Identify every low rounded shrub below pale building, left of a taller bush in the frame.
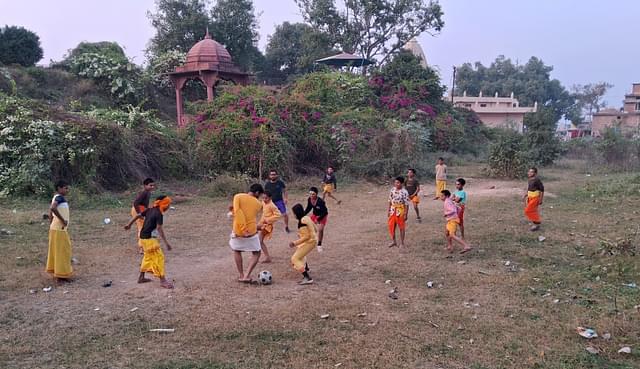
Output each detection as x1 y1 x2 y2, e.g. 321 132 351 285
488 130 528 178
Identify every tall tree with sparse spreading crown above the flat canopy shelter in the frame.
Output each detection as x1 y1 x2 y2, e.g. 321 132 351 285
295 0 444 64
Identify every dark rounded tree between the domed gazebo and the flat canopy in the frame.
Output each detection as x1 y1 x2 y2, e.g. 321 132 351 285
262 22 331 83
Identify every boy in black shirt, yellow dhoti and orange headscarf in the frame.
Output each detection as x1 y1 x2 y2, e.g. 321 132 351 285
124 196 173 288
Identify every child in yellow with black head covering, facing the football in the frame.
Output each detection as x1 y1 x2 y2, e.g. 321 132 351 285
289 201 317 285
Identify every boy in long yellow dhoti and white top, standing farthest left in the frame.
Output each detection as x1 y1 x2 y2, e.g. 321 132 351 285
46 181 73 282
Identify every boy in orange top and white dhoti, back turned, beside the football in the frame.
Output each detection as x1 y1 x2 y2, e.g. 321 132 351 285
229 183 264 283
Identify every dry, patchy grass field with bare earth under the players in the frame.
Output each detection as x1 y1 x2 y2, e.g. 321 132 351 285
0 163 640 369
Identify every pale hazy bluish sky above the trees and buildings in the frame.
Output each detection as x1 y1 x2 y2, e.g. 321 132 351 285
0 0 640 107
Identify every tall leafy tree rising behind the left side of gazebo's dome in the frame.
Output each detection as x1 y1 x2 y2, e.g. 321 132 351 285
147 0 210 57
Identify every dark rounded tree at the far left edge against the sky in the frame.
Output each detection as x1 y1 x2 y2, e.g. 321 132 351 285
0 26 43 67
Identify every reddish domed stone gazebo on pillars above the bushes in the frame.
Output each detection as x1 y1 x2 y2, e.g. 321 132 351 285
169 30 250 127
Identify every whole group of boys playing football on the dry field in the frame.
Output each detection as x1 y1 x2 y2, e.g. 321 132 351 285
46 158 544 288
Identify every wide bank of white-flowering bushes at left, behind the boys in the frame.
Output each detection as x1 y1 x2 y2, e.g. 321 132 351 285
0 93 187 196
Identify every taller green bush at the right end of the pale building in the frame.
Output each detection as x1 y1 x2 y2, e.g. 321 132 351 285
524 108 562 166
